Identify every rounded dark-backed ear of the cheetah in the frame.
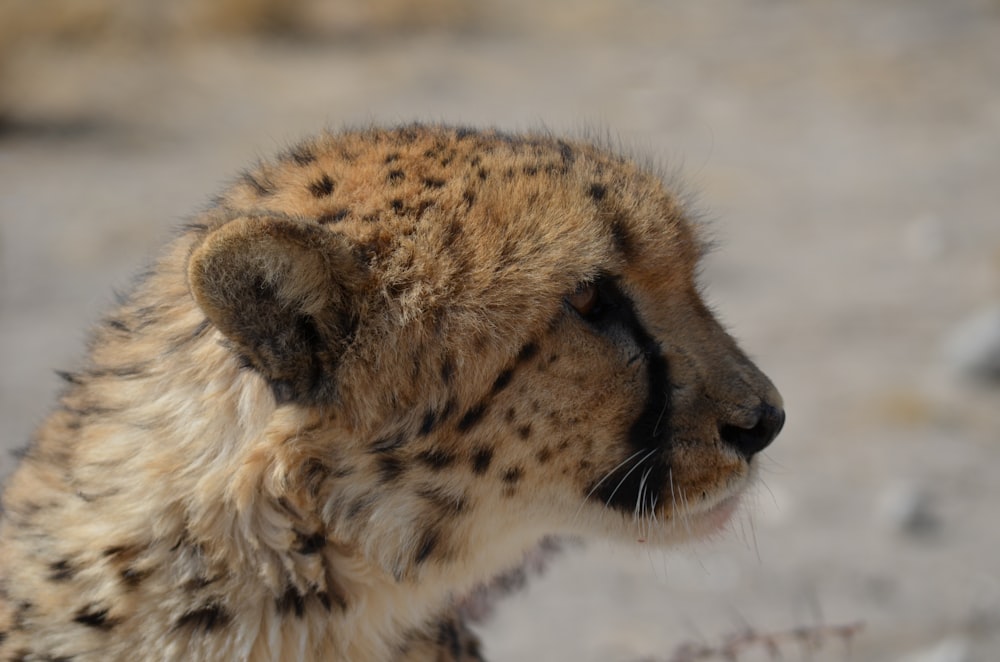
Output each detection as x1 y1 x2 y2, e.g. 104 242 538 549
188 216 365 404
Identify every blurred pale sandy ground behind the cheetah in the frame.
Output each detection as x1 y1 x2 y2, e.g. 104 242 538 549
0 0 1000 662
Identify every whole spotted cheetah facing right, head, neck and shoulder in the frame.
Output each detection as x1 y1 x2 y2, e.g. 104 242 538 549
0 124 785 662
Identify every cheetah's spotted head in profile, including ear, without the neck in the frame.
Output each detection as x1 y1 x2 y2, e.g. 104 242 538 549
188 126 784 576
